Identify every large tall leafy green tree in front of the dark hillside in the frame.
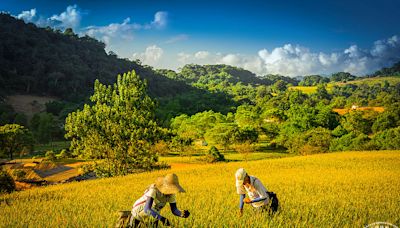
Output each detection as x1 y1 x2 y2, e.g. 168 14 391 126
65 71 163 176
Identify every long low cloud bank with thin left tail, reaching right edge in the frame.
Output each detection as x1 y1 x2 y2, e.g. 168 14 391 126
177 36 400 76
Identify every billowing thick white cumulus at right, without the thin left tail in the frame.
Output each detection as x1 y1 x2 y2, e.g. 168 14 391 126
258 36 400 76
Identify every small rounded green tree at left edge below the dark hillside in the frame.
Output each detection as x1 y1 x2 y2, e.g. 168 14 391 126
0 124 30 160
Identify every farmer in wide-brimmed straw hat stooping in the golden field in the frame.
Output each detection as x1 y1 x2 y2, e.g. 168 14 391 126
130 174 190 227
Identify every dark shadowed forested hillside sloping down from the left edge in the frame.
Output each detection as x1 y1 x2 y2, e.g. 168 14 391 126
0 14 195 101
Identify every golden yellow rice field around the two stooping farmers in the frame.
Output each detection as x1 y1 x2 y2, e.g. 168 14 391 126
0 151 400 227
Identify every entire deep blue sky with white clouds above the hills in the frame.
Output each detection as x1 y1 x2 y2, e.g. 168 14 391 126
0 0 400 76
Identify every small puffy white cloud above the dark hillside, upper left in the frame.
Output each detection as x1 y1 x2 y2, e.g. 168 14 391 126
48 5 82 29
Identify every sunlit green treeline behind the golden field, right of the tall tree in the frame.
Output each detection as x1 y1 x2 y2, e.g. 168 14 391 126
171 80 400 154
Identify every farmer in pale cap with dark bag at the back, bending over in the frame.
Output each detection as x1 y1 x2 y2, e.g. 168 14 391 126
235 168 278 216
